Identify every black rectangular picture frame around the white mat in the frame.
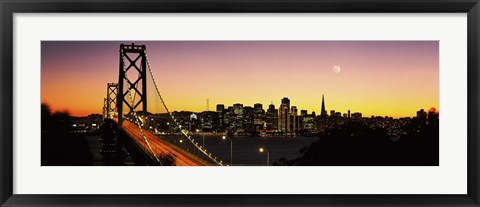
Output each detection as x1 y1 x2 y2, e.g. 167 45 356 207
0 0 480 206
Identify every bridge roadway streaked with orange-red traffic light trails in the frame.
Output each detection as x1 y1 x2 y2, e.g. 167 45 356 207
115 120 212 166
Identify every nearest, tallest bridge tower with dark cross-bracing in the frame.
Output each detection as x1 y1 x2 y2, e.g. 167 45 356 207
117 43 147 124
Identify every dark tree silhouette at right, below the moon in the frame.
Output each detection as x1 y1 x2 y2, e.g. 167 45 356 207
274 108 439 166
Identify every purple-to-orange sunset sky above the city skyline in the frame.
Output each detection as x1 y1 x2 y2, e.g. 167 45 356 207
41 41 439 118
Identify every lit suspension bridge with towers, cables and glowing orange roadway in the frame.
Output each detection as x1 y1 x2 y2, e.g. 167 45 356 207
103 43 224 166
